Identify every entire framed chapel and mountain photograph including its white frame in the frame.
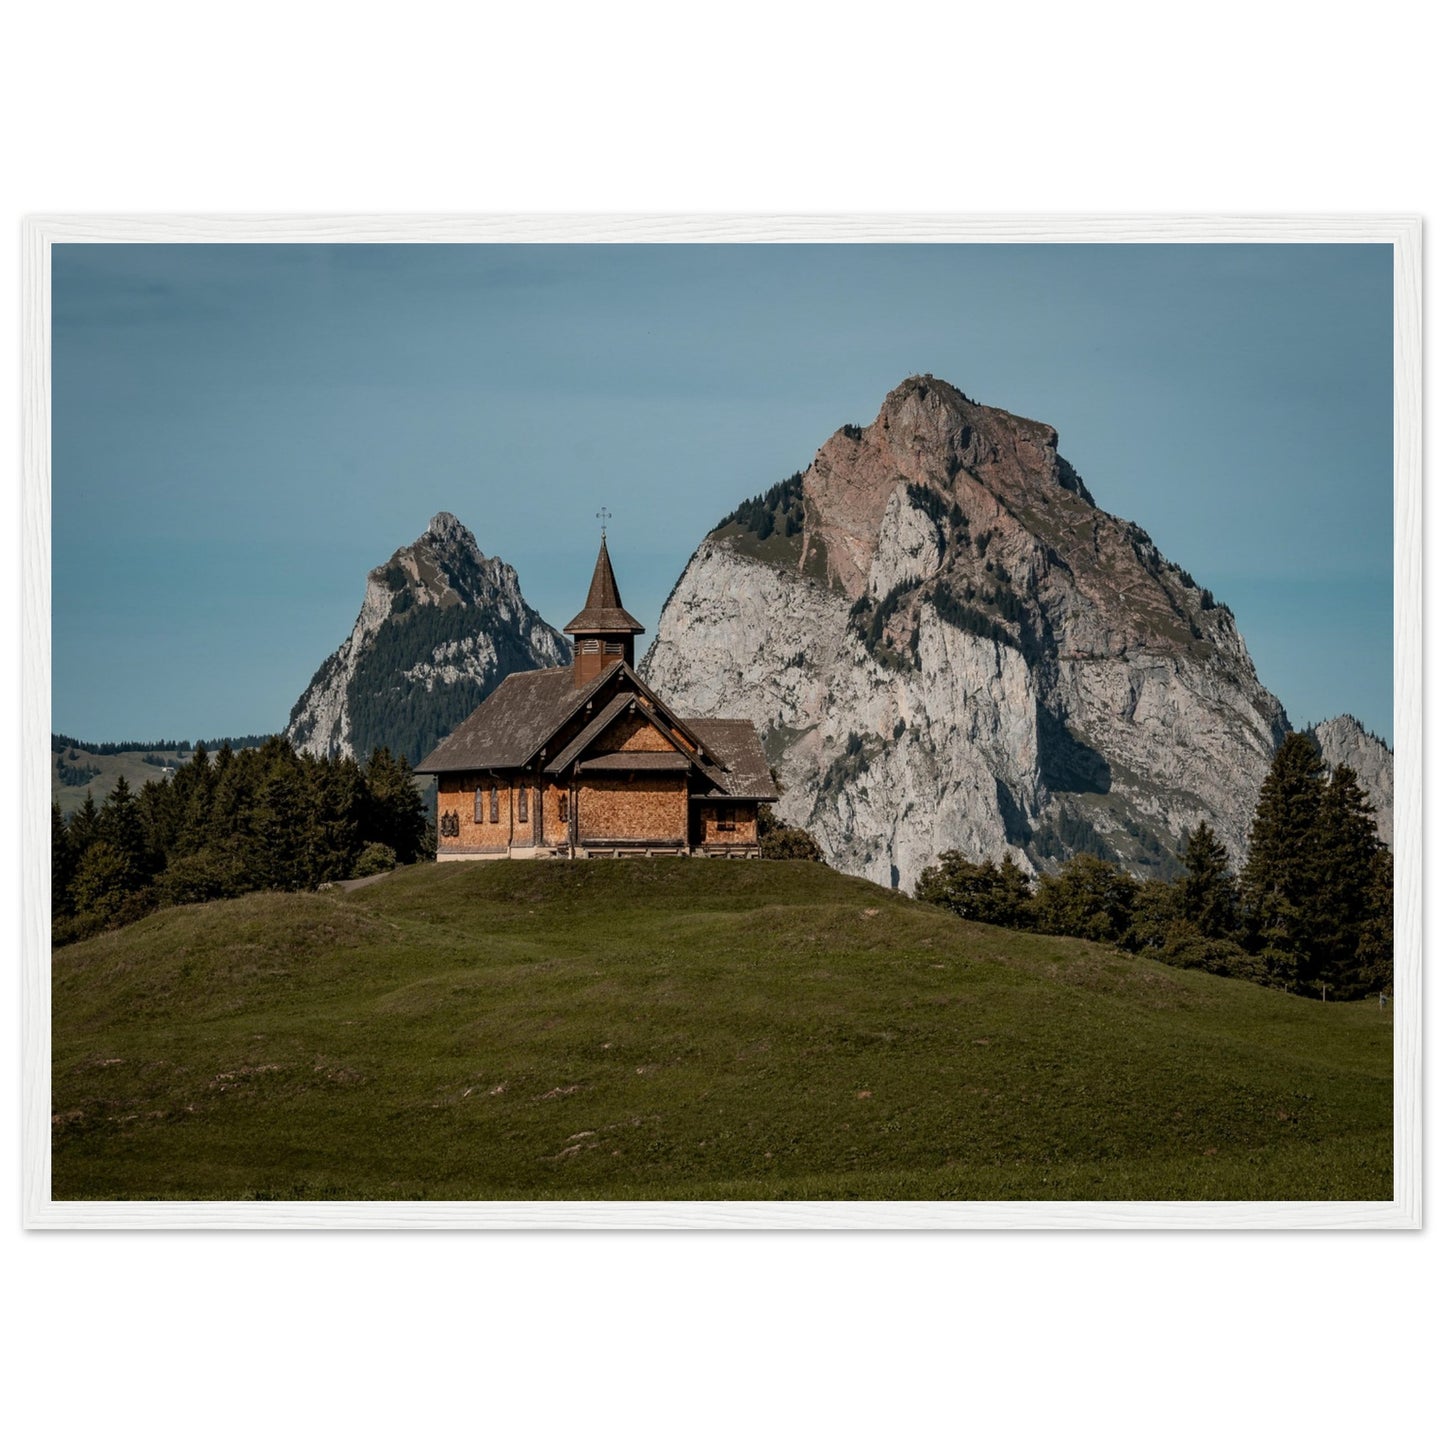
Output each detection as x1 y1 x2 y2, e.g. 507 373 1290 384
23 217 1422 1228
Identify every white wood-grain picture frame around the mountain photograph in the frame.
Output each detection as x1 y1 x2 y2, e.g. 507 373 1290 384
20 215 1423 1230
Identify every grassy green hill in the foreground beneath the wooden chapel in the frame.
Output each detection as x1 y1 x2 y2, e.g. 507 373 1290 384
53 858 1392 1199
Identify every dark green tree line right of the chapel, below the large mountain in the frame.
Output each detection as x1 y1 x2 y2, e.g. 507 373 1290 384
915 733 1394 998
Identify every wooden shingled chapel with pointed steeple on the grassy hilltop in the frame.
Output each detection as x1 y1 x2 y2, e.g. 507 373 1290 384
416 532 777 861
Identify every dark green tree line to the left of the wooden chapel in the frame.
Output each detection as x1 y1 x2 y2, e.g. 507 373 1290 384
51 737 429 945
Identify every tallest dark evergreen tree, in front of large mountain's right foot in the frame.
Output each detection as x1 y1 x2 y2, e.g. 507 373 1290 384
1240 733 1325 987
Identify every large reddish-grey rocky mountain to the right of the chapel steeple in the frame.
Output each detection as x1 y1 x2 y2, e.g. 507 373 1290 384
642 376 1289 887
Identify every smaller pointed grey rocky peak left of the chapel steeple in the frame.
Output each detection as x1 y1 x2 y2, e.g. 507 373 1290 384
286 512 572 763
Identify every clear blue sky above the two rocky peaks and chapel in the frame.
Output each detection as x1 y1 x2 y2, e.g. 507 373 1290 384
52 246 1393 741
